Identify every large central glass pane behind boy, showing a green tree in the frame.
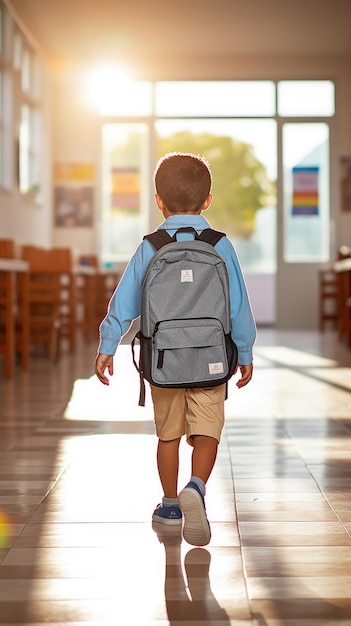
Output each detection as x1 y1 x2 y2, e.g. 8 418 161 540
155 119 277 325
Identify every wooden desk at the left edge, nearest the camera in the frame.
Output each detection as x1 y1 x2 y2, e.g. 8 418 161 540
0 259 29 378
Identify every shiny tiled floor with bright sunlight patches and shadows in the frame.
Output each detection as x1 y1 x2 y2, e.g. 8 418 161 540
0 330 351 626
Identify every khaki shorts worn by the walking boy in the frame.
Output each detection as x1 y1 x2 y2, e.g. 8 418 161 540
151 384 226 445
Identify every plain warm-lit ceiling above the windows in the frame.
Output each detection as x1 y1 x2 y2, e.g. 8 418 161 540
5 0 351 69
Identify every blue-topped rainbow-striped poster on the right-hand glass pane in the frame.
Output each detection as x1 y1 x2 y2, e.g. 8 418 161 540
291 166 319 215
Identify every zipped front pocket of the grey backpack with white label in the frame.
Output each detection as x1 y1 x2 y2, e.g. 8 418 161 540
152 318 228 387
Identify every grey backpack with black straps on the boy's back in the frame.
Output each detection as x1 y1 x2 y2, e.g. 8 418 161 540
132 227 238 406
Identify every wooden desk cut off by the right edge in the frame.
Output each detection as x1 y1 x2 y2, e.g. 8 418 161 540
333 257 351 347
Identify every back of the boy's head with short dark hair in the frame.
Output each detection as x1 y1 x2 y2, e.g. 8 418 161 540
154 152 211 213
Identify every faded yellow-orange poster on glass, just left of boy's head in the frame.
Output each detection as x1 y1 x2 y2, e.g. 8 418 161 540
111 167 140 211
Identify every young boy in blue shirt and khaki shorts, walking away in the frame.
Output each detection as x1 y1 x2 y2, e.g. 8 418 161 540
95 153 256 546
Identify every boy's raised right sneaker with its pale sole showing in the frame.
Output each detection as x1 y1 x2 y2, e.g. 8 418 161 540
179 481 211 546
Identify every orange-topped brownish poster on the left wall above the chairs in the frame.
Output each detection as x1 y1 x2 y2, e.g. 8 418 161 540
54 163 95 227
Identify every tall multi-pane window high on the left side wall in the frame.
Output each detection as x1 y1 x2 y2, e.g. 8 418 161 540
0 0 43 195
